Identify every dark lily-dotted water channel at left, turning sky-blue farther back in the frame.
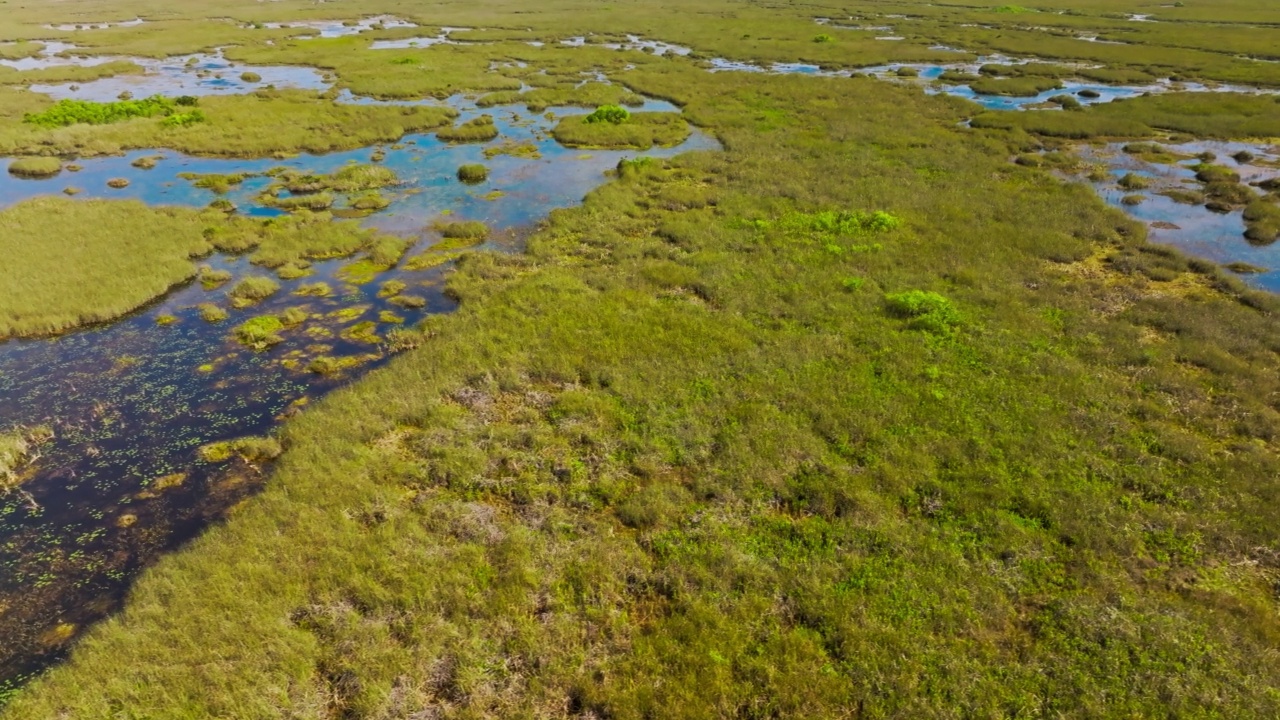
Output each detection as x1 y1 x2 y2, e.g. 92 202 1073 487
0 96 718 701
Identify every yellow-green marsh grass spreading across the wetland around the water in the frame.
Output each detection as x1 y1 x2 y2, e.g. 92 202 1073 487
0 0 1280 720
